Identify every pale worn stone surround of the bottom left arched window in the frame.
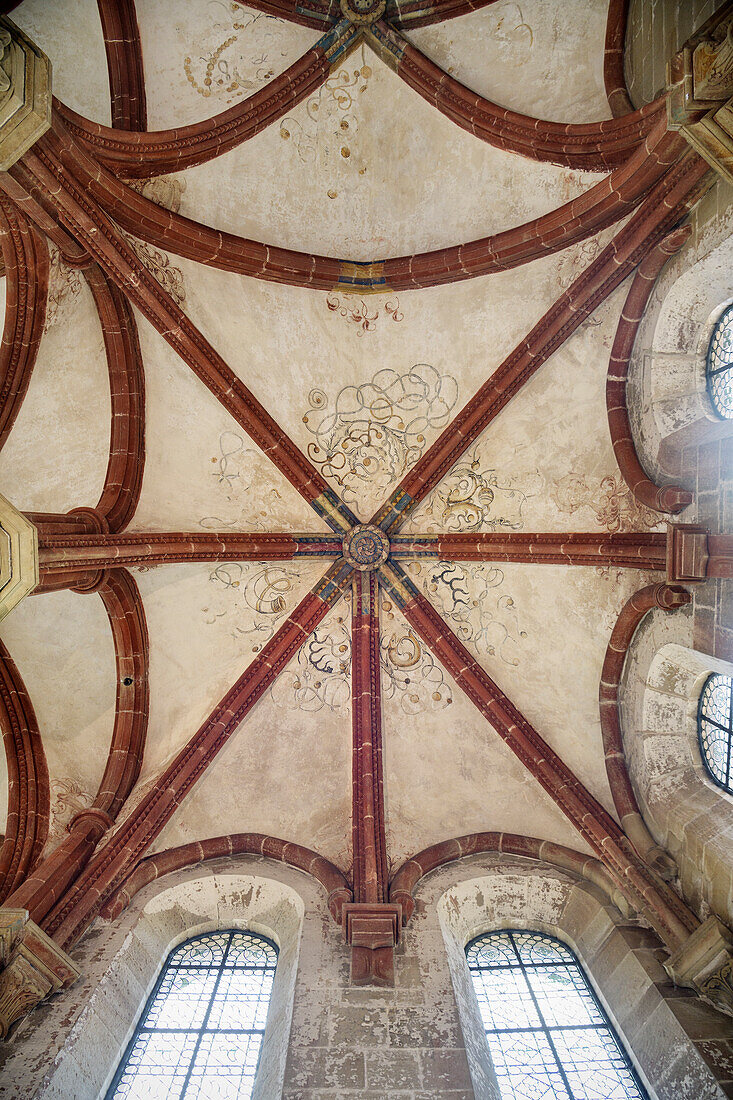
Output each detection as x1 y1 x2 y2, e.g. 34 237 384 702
19 865 305 1100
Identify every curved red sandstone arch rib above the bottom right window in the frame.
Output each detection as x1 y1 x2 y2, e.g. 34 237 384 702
390 833 619 924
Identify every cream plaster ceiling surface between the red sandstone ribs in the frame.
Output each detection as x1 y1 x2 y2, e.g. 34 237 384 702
0 0 654 867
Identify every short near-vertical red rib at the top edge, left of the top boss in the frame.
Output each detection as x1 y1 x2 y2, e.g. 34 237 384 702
97 0 147 130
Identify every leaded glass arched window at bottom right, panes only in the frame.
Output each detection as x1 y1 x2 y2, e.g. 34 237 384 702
466 931 646 1100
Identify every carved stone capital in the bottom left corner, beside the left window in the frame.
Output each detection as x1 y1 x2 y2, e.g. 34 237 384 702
0 909 80 1038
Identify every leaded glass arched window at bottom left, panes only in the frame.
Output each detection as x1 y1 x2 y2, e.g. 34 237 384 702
107 930 277 1100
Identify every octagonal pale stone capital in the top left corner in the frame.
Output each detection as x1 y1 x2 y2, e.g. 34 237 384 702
0 15 51 172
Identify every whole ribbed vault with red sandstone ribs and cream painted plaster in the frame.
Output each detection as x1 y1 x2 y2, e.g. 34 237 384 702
0 0 730 1003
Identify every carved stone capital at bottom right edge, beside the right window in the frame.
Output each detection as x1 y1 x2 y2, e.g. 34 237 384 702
665 916 733 1016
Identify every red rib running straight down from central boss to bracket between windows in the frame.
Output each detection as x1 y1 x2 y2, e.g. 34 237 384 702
351 570 387 903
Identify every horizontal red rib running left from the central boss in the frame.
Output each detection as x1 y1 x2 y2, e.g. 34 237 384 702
39 528 341 584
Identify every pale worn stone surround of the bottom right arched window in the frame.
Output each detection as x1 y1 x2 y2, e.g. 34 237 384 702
416 855 726 1100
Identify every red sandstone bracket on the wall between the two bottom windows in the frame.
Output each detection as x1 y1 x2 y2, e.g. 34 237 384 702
341 902 402 986
